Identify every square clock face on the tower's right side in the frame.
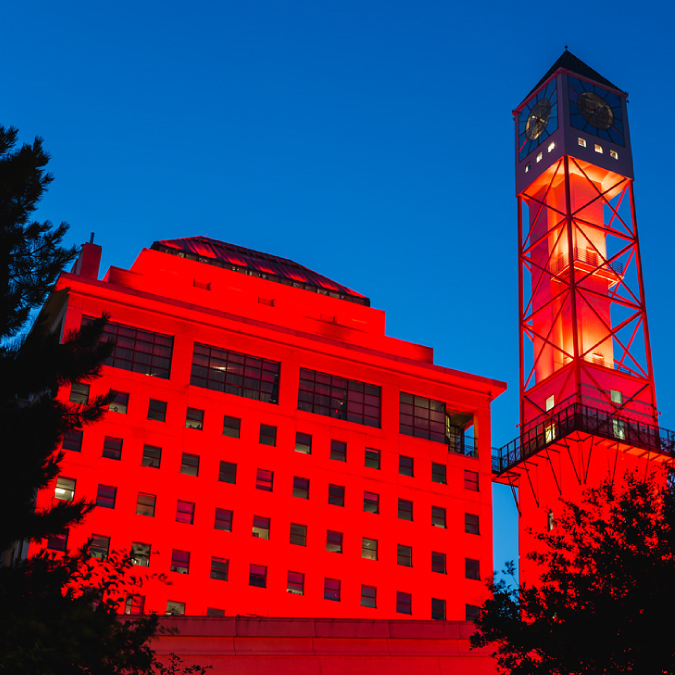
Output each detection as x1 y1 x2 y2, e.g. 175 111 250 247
568 76 626 145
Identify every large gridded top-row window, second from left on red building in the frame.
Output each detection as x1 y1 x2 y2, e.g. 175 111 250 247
190 342 280 403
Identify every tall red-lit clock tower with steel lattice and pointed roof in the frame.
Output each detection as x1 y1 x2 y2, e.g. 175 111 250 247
495 51 671 581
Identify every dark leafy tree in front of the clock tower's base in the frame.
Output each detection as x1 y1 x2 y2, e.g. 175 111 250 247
471 474 675 675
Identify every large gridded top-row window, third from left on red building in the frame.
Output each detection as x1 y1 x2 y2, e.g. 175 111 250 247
298 368 382 429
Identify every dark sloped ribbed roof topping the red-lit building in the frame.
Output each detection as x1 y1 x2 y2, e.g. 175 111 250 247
151 237 370 306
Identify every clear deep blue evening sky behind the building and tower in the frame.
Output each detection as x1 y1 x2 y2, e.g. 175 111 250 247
5 0 675 580
